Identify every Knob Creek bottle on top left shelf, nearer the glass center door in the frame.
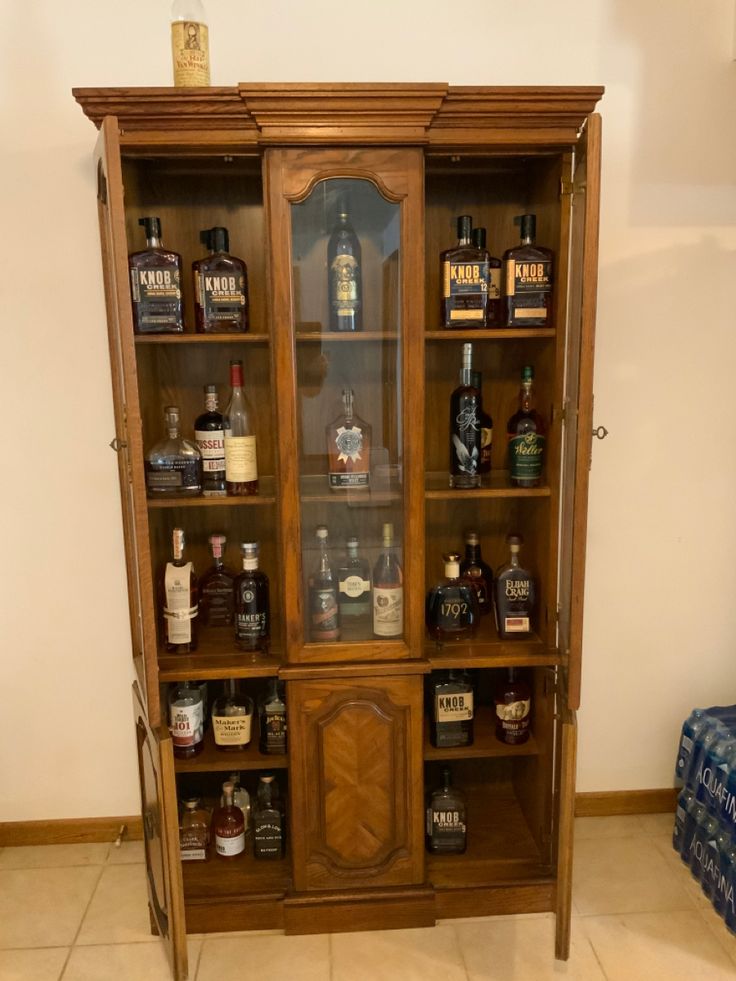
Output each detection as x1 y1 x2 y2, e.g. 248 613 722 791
192 225 248 334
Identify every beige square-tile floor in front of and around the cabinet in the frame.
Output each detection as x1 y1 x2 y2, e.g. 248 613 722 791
0 814 736 981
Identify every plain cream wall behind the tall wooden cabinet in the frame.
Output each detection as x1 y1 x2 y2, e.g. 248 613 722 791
0 0 736 820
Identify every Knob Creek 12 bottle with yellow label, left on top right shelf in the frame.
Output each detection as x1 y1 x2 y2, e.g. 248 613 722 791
440 215 488 327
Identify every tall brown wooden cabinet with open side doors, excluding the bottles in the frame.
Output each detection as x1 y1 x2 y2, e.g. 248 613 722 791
75 84 602 978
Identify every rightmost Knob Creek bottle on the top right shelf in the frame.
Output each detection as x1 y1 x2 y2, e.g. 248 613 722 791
503 215 553 327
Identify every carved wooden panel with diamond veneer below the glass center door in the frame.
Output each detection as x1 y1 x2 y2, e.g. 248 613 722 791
287 677 423 890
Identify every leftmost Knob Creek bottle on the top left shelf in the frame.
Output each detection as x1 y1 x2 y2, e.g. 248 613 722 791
128 216 184 334
